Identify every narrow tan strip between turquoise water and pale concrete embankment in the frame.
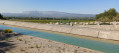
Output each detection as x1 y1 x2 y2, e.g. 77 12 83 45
0 24 119 44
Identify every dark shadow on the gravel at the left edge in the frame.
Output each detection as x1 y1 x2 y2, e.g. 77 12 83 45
0 34 22 53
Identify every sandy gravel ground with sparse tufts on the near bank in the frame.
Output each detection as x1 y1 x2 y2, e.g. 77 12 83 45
0 34 103 53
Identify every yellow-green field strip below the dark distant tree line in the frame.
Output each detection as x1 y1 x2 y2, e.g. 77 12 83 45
10 19 94 23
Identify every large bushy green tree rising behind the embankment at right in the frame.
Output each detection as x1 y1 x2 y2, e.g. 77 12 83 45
95 8 117 22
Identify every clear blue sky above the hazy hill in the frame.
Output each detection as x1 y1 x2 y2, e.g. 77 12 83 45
0 0 119 14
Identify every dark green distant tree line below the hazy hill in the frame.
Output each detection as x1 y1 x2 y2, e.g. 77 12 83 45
4 17 93 20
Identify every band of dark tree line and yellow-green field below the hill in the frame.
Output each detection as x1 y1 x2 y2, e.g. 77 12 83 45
5 17 94 23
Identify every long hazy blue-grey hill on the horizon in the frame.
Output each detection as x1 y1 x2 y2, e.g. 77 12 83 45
2 11 95 18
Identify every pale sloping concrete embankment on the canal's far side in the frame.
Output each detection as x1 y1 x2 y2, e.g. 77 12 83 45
0 20 119 40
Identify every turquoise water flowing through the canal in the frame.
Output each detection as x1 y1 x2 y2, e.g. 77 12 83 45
0 25 119 53
